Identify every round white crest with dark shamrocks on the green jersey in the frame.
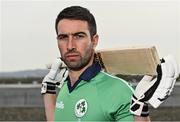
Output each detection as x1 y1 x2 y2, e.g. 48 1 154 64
74 99 88 117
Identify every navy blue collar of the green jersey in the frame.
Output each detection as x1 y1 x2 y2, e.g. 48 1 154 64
67 62 101 93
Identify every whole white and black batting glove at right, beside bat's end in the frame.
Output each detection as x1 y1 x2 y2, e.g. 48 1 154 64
130 56 179 117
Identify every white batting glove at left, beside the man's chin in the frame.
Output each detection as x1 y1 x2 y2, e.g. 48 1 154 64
41 58 68 94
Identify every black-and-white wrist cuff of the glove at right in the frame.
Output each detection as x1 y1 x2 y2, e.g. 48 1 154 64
130 95 149 117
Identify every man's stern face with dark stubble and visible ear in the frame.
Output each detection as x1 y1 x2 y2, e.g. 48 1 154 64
57 19 98 70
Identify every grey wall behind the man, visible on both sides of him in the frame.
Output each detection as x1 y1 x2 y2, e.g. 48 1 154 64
0 84 180 107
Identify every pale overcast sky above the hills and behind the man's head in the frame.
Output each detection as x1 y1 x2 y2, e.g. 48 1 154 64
0 0 180 72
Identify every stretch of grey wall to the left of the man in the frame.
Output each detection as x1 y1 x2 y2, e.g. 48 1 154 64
0 84 44 107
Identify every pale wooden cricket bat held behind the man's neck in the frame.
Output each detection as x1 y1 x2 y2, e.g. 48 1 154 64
96 46 160 75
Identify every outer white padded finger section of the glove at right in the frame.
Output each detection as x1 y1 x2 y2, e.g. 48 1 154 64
148 55 179 108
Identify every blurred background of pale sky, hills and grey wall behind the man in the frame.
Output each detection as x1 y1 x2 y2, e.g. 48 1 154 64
0 0 180 121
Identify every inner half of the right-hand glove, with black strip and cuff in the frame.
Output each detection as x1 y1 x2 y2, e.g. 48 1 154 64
130 73 161 117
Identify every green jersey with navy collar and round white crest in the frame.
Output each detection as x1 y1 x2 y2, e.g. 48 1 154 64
54 63 134 121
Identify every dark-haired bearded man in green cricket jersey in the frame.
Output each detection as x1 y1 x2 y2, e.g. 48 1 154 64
42 6 179 121
